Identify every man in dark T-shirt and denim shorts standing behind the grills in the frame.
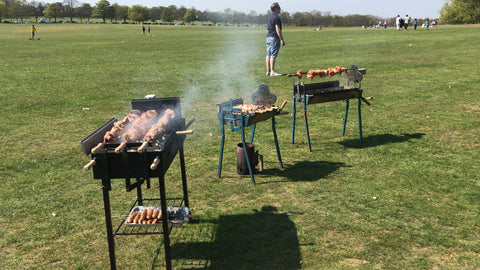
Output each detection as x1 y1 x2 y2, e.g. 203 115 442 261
266 2 285 76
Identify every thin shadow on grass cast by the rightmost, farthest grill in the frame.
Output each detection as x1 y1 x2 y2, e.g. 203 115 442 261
339 133 426 148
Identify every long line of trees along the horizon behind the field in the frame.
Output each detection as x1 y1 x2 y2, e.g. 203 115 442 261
0 0 480 27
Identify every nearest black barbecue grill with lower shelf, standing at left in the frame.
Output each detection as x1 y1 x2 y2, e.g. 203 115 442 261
81 98 193 269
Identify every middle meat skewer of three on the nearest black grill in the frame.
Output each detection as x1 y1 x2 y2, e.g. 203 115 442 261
115 110 158 154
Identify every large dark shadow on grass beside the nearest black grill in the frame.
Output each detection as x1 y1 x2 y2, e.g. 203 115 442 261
158 206 301 270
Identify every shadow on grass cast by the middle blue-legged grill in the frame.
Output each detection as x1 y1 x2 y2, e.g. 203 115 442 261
257 160 346 184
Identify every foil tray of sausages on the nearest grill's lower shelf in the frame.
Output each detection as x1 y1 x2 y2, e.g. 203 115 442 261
125 206 190 227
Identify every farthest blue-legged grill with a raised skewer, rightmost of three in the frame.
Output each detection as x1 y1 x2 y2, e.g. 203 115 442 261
291 65 370 152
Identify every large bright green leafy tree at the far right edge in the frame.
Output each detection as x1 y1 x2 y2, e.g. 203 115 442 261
440 0 480 23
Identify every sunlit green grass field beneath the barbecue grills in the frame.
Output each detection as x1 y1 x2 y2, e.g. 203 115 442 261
0 24 480 269
